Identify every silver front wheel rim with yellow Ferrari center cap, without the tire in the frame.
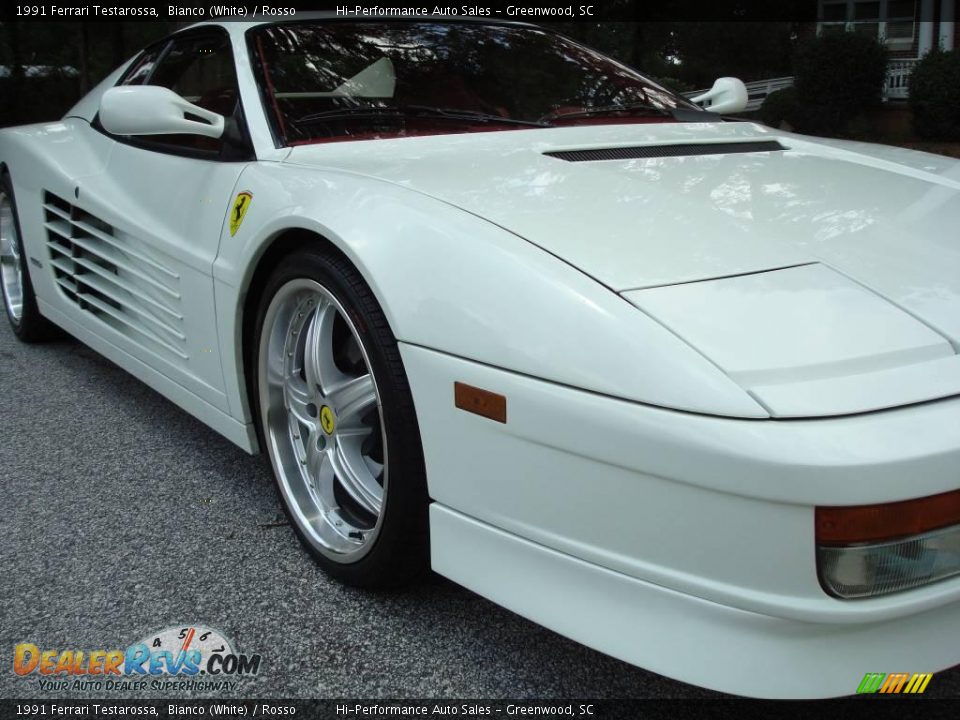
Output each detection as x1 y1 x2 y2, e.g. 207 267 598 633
258 278 388 563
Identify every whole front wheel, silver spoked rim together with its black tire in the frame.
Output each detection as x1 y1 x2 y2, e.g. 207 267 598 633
255 252 427 586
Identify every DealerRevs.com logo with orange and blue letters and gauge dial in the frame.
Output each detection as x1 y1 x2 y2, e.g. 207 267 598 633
13 625 262 691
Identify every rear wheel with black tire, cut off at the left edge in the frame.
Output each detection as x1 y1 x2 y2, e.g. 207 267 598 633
0 173 56 342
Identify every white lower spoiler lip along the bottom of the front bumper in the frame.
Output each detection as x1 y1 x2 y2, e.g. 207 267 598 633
430 504 960 698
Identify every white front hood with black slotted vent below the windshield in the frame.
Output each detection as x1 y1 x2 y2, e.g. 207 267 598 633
288 123 960 416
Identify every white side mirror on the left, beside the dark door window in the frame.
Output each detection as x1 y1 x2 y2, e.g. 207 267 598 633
100 85 224 138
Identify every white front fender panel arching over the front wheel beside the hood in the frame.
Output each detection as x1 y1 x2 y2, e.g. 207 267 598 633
214 163 767 419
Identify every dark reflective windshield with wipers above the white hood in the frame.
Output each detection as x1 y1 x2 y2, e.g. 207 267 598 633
250 21 698 145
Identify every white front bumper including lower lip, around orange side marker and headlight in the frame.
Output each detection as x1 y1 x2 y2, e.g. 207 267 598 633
402 345 960 697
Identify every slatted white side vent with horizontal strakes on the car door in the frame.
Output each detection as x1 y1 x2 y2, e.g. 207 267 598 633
43 192 188 360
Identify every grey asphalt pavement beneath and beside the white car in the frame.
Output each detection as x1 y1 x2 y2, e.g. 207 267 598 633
0 317 960 698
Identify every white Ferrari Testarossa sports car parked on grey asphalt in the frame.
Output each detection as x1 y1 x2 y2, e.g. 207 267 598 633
0 17 960 697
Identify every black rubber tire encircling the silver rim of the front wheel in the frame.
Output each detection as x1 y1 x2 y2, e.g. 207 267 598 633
248 248 429 589
